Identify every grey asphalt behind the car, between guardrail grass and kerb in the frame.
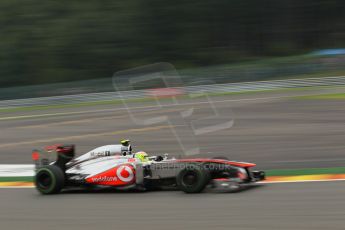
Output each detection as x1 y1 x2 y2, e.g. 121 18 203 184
0 87 345 169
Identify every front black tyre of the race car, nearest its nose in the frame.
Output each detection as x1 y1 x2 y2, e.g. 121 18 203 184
176 164 210 193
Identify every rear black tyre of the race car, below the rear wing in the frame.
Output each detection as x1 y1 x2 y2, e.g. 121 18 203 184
35 165 65 194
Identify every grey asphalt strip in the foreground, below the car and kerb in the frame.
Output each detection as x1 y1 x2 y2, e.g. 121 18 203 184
0 181 345 230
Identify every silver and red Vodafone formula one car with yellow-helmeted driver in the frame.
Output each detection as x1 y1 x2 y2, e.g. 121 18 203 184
32 144 265 194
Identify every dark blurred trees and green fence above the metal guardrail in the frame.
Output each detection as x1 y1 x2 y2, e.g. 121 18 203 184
0 0 345 99
